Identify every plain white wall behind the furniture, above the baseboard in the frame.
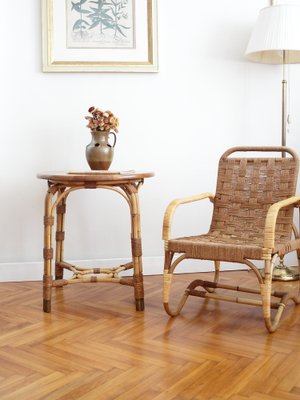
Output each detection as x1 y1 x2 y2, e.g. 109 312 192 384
0 0 300 280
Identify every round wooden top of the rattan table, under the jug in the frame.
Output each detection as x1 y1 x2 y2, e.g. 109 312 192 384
37 170 154 183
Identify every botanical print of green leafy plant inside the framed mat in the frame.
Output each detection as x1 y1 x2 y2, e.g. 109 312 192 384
66 0 135 48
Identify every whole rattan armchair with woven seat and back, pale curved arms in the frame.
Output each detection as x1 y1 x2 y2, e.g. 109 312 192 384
163 147 300 332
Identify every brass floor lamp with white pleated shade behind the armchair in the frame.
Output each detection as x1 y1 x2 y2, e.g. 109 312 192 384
245 1 300 281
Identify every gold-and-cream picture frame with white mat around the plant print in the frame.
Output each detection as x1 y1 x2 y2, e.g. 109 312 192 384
42 0 158 72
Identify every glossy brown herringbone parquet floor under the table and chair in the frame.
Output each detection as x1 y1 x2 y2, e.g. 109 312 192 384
0 271 300 400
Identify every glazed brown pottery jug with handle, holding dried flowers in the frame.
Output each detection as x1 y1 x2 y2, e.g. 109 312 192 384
85 130 117 170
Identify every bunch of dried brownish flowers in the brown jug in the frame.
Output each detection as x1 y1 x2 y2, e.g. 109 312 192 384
85 107 119 132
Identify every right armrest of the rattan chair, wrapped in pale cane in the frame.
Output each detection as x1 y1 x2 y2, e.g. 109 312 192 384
264 196 300 249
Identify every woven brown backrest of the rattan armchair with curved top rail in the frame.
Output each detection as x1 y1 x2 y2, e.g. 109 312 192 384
210 147 299 244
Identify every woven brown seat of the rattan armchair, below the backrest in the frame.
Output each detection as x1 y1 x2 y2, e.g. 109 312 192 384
168 232 300 262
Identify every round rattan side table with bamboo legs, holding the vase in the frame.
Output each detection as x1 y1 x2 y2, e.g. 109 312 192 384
37 171 154 313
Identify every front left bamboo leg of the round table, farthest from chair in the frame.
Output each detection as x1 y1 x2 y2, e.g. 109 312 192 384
43 187 56 313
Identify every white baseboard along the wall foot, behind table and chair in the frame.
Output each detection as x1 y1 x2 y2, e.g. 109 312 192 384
0 256 245 282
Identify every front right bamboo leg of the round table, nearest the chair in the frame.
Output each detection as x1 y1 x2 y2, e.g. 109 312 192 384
128 185 144 311
